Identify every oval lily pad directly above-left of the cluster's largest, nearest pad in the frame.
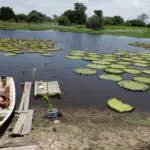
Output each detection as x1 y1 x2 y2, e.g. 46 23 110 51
99 74 123 81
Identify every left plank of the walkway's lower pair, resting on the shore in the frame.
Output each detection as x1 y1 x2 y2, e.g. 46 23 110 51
12 113 27 135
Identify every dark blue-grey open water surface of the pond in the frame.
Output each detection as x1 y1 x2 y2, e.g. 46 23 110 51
0 30 150 111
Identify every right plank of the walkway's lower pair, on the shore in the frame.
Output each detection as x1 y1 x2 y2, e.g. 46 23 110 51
21 110 33 135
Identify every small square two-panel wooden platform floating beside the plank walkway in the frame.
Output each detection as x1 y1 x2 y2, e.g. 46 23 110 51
34 81 61 96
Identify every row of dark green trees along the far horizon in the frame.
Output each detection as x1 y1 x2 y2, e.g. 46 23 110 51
0 3 150 30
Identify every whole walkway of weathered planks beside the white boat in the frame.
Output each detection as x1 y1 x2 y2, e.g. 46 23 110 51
12 82 33 136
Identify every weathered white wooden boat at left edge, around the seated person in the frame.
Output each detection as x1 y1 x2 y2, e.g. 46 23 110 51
0 77 16 127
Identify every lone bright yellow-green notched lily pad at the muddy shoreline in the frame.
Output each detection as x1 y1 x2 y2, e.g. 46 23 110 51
107 98 134 113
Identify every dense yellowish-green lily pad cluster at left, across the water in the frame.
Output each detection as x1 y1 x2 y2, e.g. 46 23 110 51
0 38 60 57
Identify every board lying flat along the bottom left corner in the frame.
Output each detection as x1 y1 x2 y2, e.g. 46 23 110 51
1 145 40 150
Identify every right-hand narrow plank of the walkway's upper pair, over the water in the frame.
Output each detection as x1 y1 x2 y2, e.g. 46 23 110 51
23 82 31 113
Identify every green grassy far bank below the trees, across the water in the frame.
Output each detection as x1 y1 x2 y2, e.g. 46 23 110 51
0 22 150 38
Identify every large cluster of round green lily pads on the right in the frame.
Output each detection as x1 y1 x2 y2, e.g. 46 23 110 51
66 50 150 91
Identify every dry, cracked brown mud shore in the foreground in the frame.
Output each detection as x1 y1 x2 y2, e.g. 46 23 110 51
0 108 150 150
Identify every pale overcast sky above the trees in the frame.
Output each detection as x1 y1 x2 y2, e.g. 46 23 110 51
0 0 150 19
